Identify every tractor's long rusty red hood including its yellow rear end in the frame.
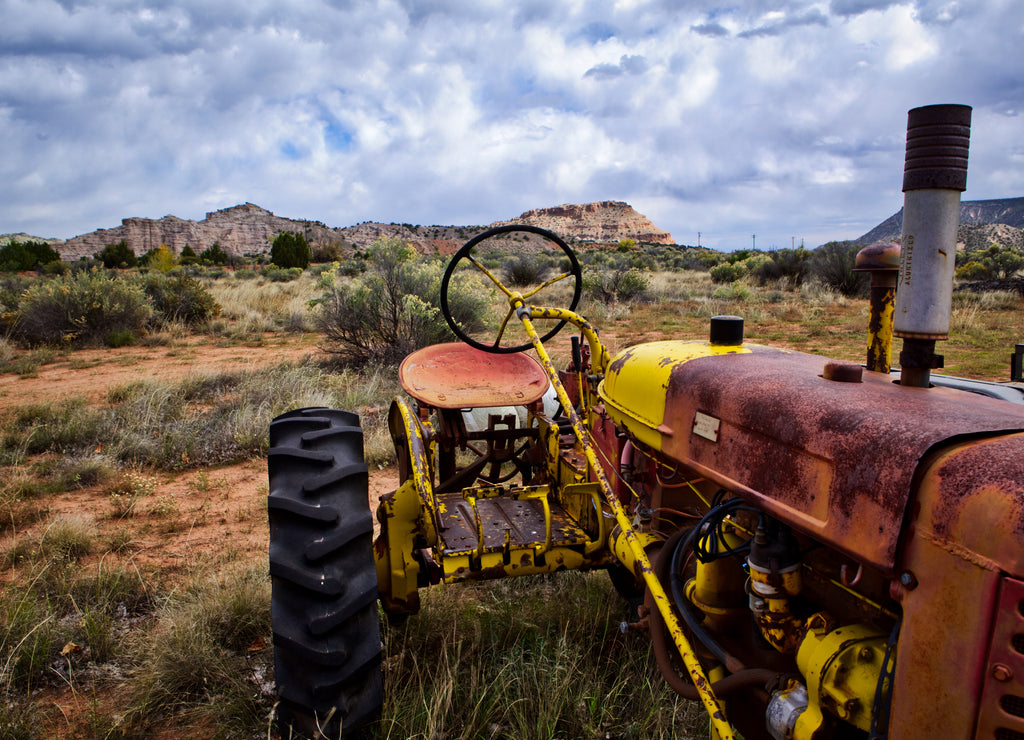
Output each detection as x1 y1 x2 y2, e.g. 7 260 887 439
598 342 1024 572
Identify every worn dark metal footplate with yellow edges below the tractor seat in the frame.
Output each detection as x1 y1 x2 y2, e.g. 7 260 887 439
437 492 588 557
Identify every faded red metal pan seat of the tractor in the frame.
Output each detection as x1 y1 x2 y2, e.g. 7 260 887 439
398 342 550 408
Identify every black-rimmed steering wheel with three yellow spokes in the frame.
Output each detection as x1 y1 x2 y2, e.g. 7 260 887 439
441 224 583 354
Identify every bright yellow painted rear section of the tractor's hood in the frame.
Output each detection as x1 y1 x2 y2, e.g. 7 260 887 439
597 341 751 450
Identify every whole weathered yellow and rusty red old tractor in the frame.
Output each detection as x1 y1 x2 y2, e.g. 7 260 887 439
268 105 1024 740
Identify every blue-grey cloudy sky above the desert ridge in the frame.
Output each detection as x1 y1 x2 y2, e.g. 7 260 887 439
0 0 1024 249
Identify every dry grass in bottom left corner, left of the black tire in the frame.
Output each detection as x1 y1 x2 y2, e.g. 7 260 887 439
0 548 273 738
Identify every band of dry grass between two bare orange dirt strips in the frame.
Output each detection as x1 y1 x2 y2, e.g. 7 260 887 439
0 364 396 474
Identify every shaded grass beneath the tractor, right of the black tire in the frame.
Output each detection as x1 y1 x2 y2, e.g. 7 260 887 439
373 572 706 738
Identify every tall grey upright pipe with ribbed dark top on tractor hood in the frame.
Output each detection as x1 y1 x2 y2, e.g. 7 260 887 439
894 105 971 388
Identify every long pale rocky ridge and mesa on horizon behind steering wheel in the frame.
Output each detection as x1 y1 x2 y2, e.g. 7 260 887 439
54 201 673 260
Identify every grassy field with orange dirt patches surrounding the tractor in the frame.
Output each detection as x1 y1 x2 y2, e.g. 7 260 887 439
0 264 1024 740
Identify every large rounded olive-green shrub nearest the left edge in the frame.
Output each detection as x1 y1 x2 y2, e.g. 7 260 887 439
9 271 152 346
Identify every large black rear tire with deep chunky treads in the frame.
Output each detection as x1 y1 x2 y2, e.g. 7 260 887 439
267 408 383 739
